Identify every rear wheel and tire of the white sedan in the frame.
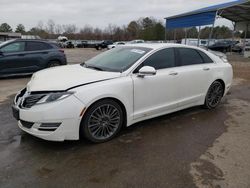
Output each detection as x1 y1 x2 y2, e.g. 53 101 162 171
204 81 224 109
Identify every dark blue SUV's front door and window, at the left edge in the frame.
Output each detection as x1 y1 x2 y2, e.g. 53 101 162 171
0 41 27 74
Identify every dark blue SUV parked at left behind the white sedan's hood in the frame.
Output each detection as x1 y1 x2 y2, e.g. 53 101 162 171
0 39 67 77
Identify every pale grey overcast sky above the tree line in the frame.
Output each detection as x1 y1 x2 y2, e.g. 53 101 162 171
0 0 232 29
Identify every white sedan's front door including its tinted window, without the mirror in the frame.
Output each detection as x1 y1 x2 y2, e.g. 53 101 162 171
132 48 177 120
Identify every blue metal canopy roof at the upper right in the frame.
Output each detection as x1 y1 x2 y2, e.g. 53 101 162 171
165 0 250 29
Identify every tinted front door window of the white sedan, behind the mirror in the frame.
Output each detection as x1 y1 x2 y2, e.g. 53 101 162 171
143 48 175 70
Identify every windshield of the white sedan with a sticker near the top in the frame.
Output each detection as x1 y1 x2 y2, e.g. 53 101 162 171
82 47 151 72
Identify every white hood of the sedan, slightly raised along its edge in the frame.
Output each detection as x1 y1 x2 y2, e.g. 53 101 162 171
27 64 121 92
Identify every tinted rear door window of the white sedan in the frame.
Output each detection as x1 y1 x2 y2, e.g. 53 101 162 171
178 48 204 66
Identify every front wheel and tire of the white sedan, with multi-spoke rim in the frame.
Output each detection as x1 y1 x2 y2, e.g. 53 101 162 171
80 99 124 143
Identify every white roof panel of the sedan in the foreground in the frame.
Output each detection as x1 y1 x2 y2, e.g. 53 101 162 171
125 43 204 50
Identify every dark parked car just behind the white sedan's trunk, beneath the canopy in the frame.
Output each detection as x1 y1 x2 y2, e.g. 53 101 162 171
208 40 239 53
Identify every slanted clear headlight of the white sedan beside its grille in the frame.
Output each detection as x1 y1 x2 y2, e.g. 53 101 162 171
36 92 74 104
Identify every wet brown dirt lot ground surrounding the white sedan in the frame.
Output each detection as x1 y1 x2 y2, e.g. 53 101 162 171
0 49 250 188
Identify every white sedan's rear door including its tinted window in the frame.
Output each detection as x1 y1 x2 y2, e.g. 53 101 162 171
176 48 215 107
